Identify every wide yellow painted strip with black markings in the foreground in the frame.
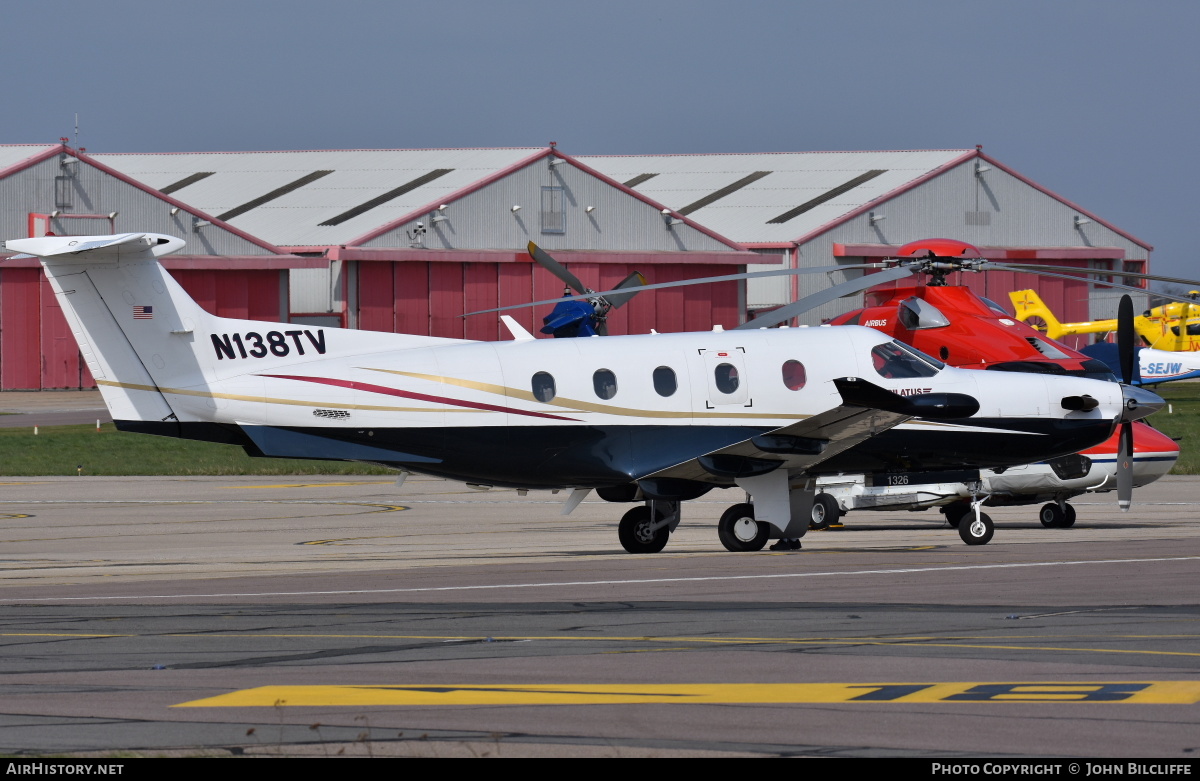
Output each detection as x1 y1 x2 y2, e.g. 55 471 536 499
173 680 1200 708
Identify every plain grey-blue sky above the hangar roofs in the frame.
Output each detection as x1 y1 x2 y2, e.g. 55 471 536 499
0 0 1200 277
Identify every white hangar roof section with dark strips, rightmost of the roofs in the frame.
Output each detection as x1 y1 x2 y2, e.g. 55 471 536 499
576 149 976 244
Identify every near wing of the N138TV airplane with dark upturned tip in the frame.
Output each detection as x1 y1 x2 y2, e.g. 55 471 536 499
647 377 921 482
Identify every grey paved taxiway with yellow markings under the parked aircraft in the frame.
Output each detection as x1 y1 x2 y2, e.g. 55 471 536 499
0 477 1200 761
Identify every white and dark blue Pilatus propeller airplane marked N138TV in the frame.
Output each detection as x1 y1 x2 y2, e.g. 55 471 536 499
6 233 1163 553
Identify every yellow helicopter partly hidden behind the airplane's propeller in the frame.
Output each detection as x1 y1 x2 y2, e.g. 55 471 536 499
1008 290 1200 353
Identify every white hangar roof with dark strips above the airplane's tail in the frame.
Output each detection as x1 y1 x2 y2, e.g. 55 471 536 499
90 148 546 246
